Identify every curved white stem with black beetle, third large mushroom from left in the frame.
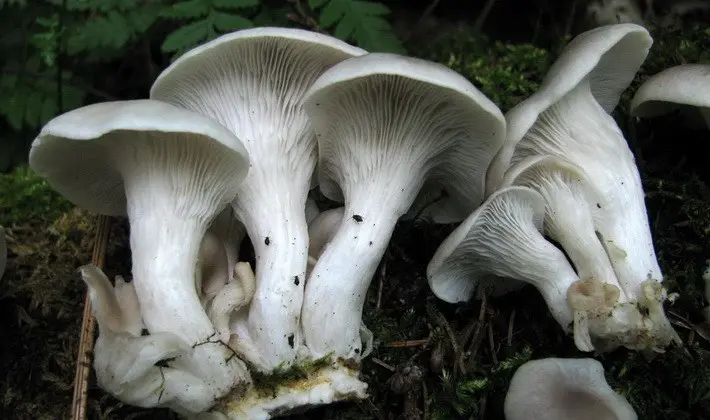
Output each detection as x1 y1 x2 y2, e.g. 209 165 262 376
302 182 424 360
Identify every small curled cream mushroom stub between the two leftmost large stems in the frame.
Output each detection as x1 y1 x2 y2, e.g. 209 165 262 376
208 262 256 344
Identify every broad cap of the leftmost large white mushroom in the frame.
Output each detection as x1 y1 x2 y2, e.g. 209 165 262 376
29 99 249 216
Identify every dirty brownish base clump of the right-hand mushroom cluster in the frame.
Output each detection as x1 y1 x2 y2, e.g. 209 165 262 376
567 280 680 353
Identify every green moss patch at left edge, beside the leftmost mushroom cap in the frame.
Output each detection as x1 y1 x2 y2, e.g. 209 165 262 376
0 167 72 226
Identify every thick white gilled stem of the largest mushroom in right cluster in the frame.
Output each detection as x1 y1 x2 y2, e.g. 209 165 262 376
513 80 663 300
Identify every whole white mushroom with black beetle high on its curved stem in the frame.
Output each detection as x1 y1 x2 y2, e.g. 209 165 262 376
302 53 505 360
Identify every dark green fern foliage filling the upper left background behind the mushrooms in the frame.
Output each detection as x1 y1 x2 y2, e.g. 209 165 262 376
0 0 404 170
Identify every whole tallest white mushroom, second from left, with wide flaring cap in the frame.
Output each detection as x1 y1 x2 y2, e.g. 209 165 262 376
150 27 365 372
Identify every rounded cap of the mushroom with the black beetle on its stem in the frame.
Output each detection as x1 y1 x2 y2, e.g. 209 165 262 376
306 53 505 221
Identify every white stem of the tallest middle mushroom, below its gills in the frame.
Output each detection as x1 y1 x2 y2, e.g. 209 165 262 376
232 190 310 372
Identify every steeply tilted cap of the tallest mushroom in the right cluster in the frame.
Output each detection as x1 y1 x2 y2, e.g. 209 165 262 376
486 23 653 194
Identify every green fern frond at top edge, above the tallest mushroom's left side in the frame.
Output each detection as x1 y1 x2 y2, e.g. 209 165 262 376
162 0 261 56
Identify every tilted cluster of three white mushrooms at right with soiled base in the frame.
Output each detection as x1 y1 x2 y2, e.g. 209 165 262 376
428 24 679 352
